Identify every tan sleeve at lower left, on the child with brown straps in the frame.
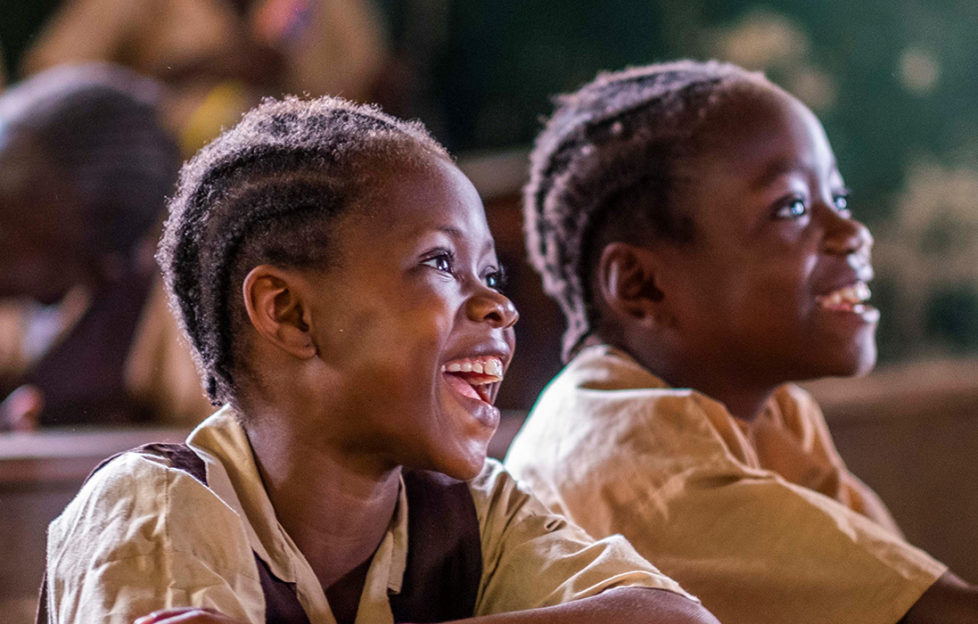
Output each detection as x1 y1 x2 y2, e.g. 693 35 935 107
47 453 265 624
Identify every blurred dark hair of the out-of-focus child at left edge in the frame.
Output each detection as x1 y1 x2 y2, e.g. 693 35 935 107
0 63 180 255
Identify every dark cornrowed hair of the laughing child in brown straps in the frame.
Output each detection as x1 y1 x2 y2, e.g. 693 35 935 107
156 97 448 404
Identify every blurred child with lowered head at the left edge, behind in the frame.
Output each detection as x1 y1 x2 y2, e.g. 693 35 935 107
0 64 209 429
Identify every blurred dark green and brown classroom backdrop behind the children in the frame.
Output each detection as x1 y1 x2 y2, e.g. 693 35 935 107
0 0 978 621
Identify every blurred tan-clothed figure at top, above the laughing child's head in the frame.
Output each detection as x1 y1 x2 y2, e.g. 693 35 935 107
22 0 387 155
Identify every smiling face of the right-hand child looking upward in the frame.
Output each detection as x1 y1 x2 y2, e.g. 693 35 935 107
652 88 879 388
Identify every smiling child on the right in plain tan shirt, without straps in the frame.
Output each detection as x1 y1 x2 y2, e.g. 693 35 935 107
506 61 978 624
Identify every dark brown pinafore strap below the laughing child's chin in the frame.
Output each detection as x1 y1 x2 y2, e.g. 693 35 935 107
390 470 482 622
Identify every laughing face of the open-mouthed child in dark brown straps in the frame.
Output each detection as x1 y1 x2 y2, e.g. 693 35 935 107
300 159 518 478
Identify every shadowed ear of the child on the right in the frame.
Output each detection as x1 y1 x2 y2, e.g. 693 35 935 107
597 242 664 323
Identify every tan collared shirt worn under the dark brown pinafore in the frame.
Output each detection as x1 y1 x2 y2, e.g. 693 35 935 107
47 408 682 624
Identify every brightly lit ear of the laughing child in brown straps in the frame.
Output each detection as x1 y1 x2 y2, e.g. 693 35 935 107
242 264 316 359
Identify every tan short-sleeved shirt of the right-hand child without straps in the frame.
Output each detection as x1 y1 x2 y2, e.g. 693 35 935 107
506 346 946 624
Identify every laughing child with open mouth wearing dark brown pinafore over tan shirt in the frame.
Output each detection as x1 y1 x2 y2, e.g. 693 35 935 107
45 98 716 624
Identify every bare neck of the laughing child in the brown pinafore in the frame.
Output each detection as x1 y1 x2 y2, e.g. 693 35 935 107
246 415 400 590
